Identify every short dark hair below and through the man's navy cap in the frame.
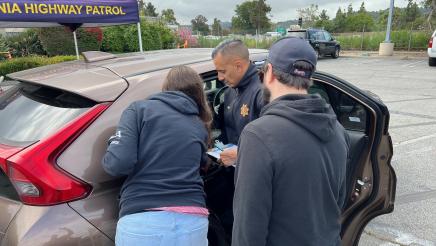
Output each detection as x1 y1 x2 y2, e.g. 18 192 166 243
264 61 314 90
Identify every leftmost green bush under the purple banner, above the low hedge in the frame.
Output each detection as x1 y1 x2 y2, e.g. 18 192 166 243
5 29 45 57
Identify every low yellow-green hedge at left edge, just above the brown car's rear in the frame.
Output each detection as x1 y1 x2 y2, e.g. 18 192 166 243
0 56 76 76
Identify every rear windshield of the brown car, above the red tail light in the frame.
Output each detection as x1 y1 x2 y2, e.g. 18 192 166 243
0 83 96 146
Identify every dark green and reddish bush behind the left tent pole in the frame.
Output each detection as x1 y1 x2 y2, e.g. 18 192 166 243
39 27 102 56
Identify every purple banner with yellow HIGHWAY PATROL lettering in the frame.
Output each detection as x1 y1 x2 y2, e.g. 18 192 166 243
0 0 139 23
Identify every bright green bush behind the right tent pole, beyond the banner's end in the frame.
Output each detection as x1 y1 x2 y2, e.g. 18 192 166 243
102 21 176 53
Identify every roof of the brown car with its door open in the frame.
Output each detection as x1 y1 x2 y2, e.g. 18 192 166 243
8 48 267 102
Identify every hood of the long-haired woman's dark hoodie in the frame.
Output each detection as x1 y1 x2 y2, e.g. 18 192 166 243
148 91 199 115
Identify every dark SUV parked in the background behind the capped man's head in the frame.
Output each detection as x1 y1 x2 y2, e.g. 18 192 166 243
287 29 341 59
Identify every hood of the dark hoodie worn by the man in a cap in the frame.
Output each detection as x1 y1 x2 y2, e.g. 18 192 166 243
261 94 337 142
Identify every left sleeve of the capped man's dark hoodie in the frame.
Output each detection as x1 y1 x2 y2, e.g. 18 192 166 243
232 130 273 246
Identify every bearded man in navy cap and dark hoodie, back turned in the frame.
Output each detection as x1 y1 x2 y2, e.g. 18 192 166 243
232 37 348 246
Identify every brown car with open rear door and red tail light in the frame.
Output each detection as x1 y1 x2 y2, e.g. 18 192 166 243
0 49 396 246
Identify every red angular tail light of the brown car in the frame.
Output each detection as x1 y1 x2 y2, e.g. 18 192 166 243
5 104 109 206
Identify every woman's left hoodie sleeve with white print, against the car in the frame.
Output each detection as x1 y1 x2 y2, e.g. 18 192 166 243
102 104 139 177
